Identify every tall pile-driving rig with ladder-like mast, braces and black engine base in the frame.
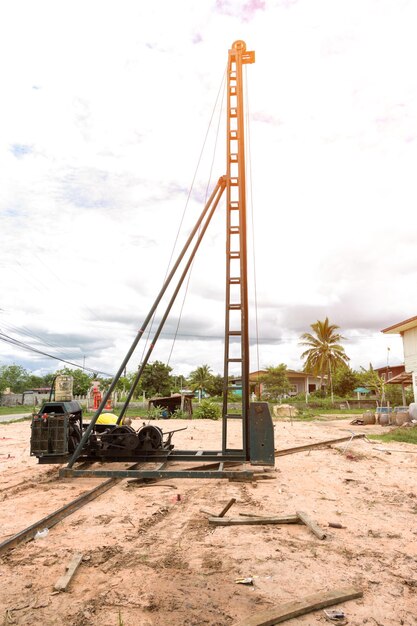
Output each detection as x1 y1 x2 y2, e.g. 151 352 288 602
32 41 275 478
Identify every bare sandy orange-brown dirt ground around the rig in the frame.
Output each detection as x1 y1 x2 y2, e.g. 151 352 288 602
0 420 417 626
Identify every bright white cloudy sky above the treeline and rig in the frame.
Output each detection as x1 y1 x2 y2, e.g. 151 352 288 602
0 0 417 375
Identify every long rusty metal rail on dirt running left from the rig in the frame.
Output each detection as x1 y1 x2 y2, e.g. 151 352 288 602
0 464 137 556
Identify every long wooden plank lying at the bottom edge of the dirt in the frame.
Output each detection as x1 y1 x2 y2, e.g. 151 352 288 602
235 587 363 626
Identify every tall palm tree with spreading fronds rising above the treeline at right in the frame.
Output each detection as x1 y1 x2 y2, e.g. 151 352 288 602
300 317 349 402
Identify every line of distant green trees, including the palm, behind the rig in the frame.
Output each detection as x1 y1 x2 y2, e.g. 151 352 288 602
0 317 413 411
